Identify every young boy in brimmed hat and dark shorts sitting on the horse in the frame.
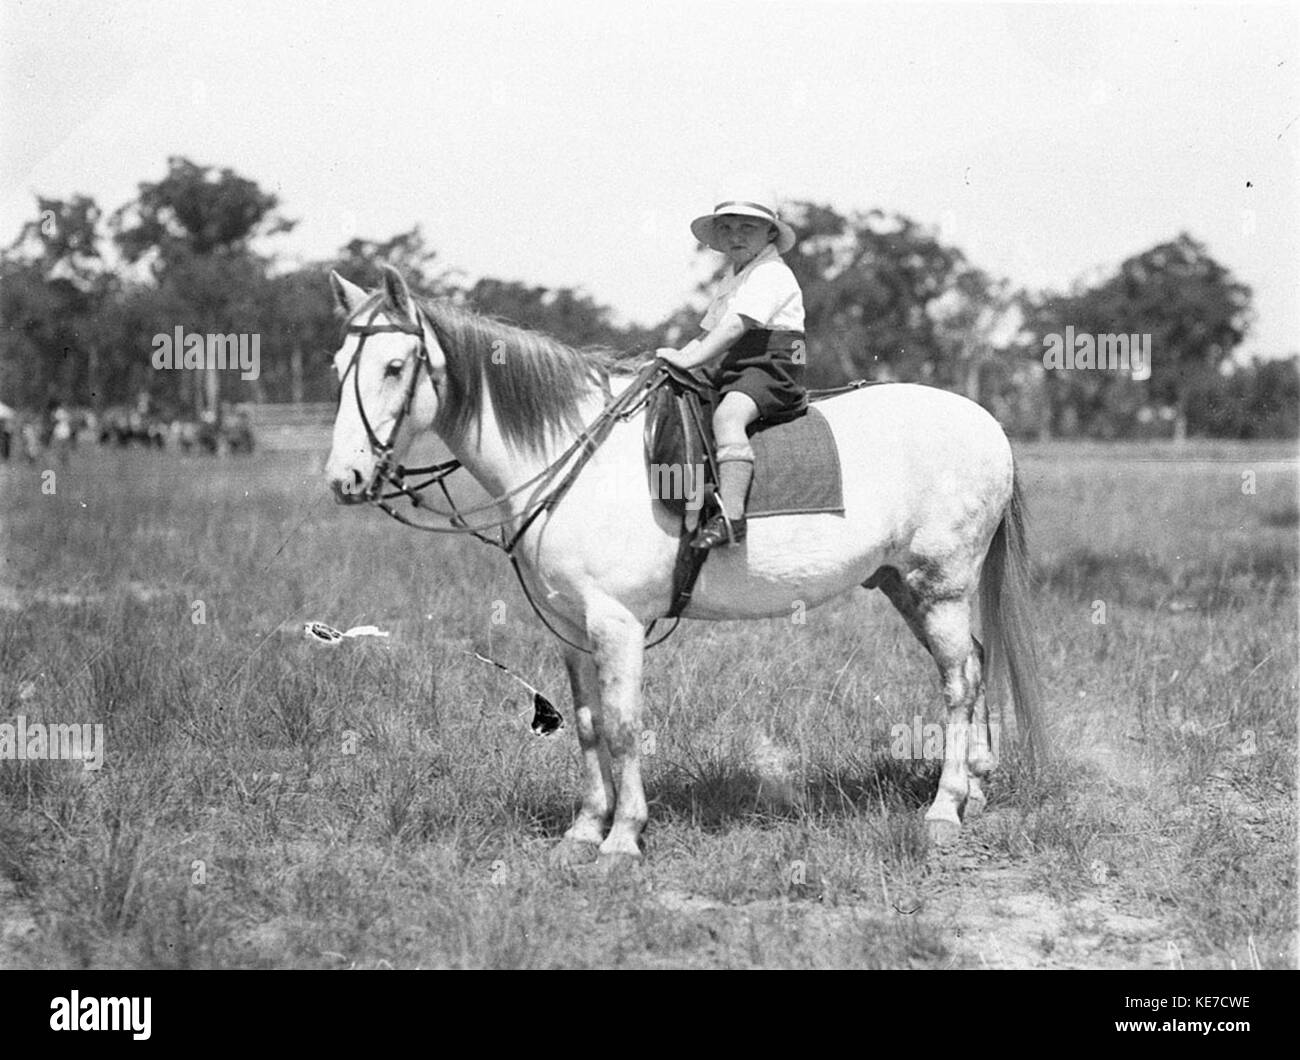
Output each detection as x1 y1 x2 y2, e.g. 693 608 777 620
658 199 807 549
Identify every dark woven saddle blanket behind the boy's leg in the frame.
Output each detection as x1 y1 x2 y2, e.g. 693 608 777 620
745 404 844 519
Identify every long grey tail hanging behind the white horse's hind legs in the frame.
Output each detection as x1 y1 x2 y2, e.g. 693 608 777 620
980 470 1048 763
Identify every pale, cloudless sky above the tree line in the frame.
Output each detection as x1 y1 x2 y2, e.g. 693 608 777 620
0 0 1300 358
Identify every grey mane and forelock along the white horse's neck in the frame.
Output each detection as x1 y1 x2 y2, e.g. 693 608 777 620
350 289 646 450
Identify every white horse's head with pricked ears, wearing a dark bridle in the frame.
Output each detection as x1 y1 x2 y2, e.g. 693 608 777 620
325 265 446 503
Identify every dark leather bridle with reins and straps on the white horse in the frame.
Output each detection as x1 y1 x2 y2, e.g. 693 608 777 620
339 306 677 652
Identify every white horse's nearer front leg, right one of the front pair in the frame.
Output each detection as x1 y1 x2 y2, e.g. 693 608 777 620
588 606 647 869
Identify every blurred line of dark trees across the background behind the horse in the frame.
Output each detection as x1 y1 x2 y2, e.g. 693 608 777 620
0 157 1300 438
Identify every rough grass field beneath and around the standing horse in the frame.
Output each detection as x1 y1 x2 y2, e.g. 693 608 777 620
0 434 1300 968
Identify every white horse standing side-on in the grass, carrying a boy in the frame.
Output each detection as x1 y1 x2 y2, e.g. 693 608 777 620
326 267 1047 866
